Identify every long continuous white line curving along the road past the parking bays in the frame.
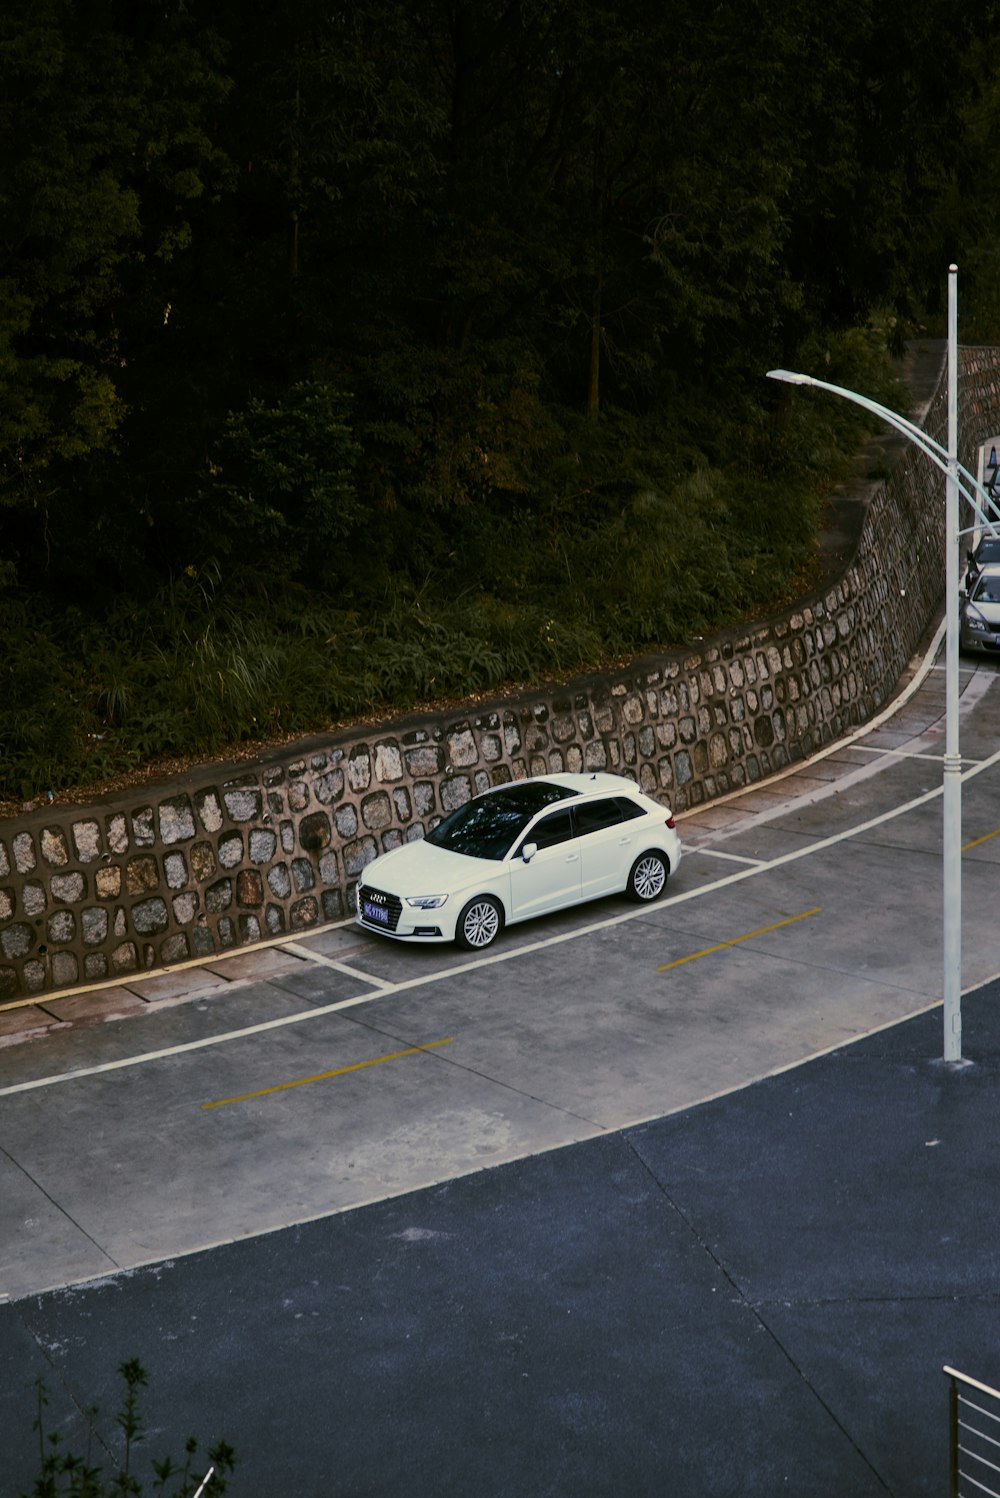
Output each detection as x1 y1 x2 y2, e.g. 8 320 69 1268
0 750 1000 1098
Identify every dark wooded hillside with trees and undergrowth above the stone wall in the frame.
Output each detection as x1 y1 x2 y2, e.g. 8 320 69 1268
0 0 1000 795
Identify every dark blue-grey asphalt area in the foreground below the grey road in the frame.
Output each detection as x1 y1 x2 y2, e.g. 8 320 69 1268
0 983 1000 1498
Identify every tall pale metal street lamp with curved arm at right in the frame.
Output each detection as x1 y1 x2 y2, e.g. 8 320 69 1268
768 265 997 1064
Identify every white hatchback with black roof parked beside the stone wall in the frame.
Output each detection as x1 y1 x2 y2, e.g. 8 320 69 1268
356 774 681 950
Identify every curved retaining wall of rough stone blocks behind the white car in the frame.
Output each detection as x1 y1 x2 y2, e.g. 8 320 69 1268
0 349 1000 1002
